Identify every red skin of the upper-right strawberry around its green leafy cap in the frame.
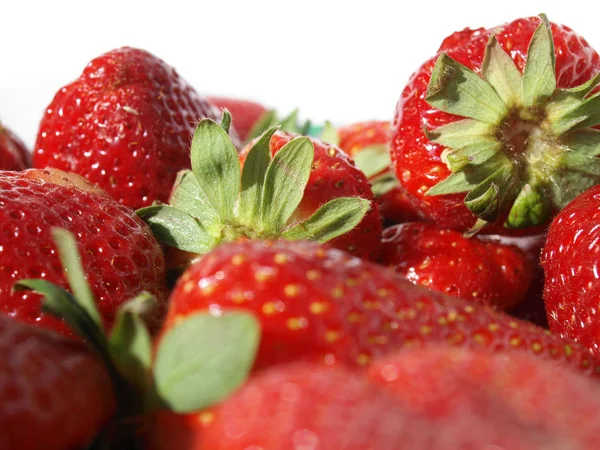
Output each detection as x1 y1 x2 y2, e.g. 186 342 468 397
391 18 600 234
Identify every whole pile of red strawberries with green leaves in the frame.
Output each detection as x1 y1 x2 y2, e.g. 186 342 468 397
0 15 600 450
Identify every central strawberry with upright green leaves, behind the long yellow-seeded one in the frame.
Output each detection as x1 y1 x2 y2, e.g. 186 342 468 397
138 113 381 264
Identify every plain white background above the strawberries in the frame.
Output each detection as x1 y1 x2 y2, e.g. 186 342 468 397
0 0 600 146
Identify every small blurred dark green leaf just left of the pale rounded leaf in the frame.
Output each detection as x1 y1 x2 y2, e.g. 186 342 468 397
108 292 156 392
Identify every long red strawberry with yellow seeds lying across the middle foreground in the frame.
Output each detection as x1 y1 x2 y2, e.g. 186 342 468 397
162 241 595 372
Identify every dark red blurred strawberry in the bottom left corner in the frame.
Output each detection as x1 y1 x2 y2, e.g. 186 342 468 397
0 314 115 450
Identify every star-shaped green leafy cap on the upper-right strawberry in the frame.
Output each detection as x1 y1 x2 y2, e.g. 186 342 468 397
424 15 600 228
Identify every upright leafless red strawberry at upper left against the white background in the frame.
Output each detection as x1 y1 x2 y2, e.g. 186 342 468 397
33 47 237 208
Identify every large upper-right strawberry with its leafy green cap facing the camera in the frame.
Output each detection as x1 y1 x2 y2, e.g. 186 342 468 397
391 15 600 234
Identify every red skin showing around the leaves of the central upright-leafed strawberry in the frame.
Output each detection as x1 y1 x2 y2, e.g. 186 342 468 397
240 132 381 260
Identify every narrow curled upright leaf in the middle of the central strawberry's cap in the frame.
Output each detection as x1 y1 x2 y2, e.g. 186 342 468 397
238 126 277 225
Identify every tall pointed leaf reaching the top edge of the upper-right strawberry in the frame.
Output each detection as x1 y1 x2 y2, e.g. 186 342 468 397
523 14 556 107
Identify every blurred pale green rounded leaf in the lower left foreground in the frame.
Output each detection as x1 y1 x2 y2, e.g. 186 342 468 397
154 311 260 413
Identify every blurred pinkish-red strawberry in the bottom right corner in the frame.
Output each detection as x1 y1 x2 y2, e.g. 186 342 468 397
368 347 600 449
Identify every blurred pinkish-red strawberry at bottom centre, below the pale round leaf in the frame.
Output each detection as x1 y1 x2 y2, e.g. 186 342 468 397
150 364 560 450
